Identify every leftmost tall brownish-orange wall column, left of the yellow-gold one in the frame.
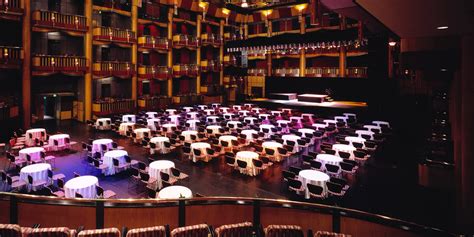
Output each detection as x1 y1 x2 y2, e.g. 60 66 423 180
22 0 31 129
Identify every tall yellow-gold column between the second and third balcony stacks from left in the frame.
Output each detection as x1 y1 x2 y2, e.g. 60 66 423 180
84 0 94 120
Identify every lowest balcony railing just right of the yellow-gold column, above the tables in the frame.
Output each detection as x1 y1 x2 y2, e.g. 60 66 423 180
92 99 135 116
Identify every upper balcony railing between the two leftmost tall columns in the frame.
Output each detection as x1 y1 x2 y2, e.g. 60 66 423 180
33 10 87 31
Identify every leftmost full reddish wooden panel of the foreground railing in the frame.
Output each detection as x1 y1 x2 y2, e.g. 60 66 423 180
18 203 96 229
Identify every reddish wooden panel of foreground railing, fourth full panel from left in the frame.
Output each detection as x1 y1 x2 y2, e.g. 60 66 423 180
260 207 332 232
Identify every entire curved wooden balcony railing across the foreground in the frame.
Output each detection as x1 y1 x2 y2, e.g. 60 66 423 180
0 193 457 237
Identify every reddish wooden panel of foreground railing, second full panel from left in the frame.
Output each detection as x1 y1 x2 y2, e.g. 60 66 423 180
104 207 178 229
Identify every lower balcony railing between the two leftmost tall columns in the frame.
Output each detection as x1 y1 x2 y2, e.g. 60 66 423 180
32 55 87 75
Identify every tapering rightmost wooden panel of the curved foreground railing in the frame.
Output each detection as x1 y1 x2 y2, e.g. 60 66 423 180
341 217 418 237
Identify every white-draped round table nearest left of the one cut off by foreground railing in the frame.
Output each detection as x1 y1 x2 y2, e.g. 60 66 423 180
64 175 99 199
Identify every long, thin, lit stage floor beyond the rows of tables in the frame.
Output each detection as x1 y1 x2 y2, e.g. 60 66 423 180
250 98 367 109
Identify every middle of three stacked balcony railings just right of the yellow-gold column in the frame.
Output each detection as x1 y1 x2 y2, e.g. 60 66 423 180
93 61 135 78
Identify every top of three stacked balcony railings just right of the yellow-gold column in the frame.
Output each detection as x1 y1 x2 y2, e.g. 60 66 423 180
93 27 137 44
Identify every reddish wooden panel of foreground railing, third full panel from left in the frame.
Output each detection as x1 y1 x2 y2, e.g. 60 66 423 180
186 205 253 227
